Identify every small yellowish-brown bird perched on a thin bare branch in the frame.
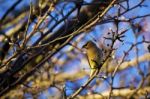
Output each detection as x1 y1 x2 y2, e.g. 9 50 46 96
82 41 103 77
